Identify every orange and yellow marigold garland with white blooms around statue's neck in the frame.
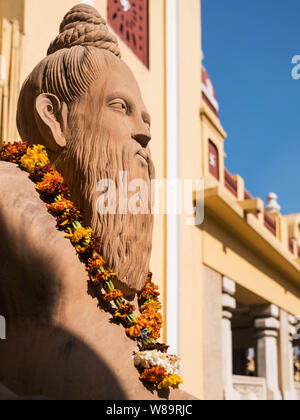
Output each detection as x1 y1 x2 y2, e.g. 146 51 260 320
0 142 182 390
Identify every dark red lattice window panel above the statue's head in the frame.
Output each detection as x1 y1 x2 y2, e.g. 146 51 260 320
107 0 149 68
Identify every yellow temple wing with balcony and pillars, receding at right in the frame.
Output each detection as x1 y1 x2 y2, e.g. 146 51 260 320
200 68 300 400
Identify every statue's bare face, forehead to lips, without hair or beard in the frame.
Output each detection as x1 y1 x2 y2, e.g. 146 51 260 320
95 61 151 181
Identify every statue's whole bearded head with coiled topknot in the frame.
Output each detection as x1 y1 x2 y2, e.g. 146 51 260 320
17 4 155 295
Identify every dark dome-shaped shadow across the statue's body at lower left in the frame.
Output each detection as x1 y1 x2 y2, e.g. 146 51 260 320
0 326 127 400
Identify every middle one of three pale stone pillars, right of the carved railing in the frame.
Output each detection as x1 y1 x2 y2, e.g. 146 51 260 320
254 305 282 400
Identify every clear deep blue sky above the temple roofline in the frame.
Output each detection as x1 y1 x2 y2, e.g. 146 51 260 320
202 0 300 214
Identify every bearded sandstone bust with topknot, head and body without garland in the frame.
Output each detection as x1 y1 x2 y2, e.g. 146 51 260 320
0 4 189 400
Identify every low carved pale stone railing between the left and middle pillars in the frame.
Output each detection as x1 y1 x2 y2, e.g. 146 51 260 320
232 375 267 401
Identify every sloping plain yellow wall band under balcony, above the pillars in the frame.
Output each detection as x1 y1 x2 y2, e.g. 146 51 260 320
202 214 300 315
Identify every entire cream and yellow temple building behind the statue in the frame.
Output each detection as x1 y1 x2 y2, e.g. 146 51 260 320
0 0 300 400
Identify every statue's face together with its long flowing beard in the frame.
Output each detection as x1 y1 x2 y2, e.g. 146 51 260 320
54 56 155 294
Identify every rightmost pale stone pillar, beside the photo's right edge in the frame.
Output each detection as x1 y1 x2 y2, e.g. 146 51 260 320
279 309 297 400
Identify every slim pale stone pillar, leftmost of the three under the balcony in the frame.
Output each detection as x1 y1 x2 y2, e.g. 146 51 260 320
222 277 236 400
